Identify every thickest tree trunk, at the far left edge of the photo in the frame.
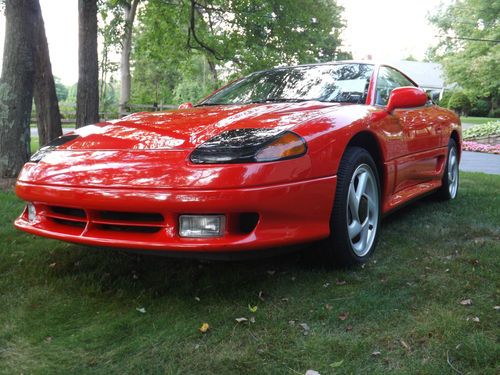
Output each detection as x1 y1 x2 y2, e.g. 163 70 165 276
0 0 37 178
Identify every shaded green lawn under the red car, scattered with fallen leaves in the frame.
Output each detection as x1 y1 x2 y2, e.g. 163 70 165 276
0 173 500 375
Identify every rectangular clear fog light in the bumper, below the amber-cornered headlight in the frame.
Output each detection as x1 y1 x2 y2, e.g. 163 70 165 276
179 215 226 238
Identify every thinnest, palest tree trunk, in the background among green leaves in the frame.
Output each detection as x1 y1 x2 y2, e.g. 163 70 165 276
119 0 139 116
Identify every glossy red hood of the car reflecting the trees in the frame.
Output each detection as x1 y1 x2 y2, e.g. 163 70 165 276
64 101 339 150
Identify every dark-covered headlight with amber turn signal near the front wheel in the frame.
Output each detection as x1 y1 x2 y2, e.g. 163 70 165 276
190 128 307 164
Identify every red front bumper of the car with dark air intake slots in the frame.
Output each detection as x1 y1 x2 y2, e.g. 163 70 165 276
15 176 336 253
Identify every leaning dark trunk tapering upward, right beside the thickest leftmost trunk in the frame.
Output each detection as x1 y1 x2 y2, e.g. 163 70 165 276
33 2 62 146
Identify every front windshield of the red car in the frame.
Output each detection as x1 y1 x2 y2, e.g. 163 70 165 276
199 63 373 106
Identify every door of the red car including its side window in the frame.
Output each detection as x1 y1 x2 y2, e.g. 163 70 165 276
374 66 443 192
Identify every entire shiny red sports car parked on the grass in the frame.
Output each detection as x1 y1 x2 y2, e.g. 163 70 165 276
15 61 461 264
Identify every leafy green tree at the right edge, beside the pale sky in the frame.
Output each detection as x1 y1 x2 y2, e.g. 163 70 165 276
430 0 500 113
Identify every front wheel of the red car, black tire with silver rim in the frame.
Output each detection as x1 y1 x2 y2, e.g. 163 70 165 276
320 147 381 266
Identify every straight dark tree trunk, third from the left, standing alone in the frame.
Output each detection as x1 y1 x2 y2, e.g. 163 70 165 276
76 0 99 128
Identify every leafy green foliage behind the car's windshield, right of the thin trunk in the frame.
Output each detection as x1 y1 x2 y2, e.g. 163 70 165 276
132 0 349 103
